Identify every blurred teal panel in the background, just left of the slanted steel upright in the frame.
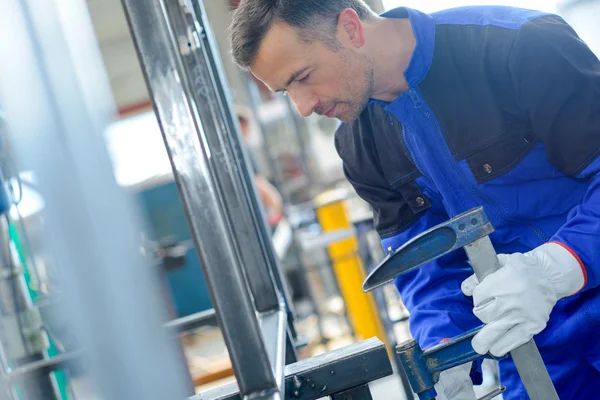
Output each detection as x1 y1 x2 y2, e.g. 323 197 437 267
136 180 213 317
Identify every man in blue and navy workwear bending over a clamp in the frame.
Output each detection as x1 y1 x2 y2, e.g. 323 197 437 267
231 0 600 400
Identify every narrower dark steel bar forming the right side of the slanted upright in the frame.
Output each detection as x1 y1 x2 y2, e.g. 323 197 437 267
185 0 281 312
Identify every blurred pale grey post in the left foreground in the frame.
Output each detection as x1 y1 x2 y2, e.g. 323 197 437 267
0 0 189 400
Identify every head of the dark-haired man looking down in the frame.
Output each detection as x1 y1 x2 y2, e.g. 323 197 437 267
231 0 377 121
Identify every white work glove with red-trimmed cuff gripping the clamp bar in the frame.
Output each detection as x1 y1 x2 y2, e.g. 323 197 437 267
462 243 586 357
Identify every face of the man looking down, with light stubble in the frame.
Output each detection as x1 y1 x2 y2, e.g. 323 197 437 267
251 23 373 122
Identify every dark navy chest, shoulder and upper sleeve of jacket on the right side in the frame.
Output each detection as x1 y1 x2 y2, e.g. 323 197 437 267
419 11 600 183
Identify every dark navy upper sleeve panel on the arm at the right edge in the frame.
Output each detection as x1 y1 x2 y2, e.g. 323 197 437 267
508 16 600 176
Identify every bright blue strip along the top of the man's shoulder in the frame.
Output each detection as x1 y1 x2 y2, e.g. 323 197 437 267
431 6 550 29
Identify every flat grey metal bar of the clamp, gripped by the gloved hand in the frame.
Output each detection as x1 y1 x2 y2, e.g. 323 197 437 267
464 236 558 400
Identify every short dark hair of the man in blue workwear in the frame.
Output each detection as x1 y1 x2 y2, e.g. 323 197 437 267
230 0 376 69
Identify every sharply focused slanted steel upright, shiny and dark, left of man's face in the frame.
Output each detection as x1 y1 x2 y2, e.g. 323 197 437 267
123 0 286 399
